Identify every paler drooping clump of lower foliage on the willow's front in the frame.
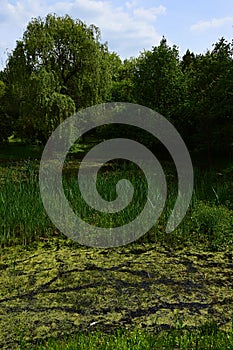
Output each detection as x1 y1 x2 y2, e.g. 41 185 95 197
18 68 75 142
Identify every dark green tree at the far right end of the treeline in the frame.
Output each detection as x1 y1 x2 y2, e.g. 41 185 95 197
183 38 233 159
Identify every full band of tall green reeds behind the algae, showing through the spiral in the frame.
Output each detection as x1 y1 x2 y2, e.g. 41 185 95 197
0 161 233 249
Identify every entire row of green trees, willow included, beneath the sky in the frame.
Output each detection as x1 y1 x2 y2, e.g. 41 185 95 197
0 15 233 156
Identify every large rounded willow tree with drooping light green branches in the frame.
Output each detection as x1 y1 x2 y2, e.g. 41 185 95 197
6 14 111 140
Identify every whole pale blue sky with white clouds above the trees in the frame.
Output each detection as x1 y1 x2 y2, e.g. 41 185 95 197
0 0 233 69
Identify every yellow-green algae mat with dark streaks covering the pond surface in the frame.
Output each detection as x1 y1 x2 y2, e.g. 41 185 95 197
0 241 233 349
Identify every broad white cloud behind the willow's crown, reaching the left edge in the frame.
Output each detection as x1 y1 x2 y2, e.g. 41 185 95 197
0 0 166 67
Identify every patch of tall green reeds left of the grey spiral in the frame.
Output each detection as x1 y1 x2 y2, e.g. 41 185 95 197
0 163 52 244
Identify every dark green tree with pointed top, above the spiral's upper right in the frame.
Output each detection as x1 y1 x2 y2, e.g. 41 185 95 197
134 38 184 120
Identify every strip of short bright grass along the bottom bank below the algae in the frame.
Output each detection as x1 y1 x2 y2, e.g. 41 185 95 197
19 323 233 350
